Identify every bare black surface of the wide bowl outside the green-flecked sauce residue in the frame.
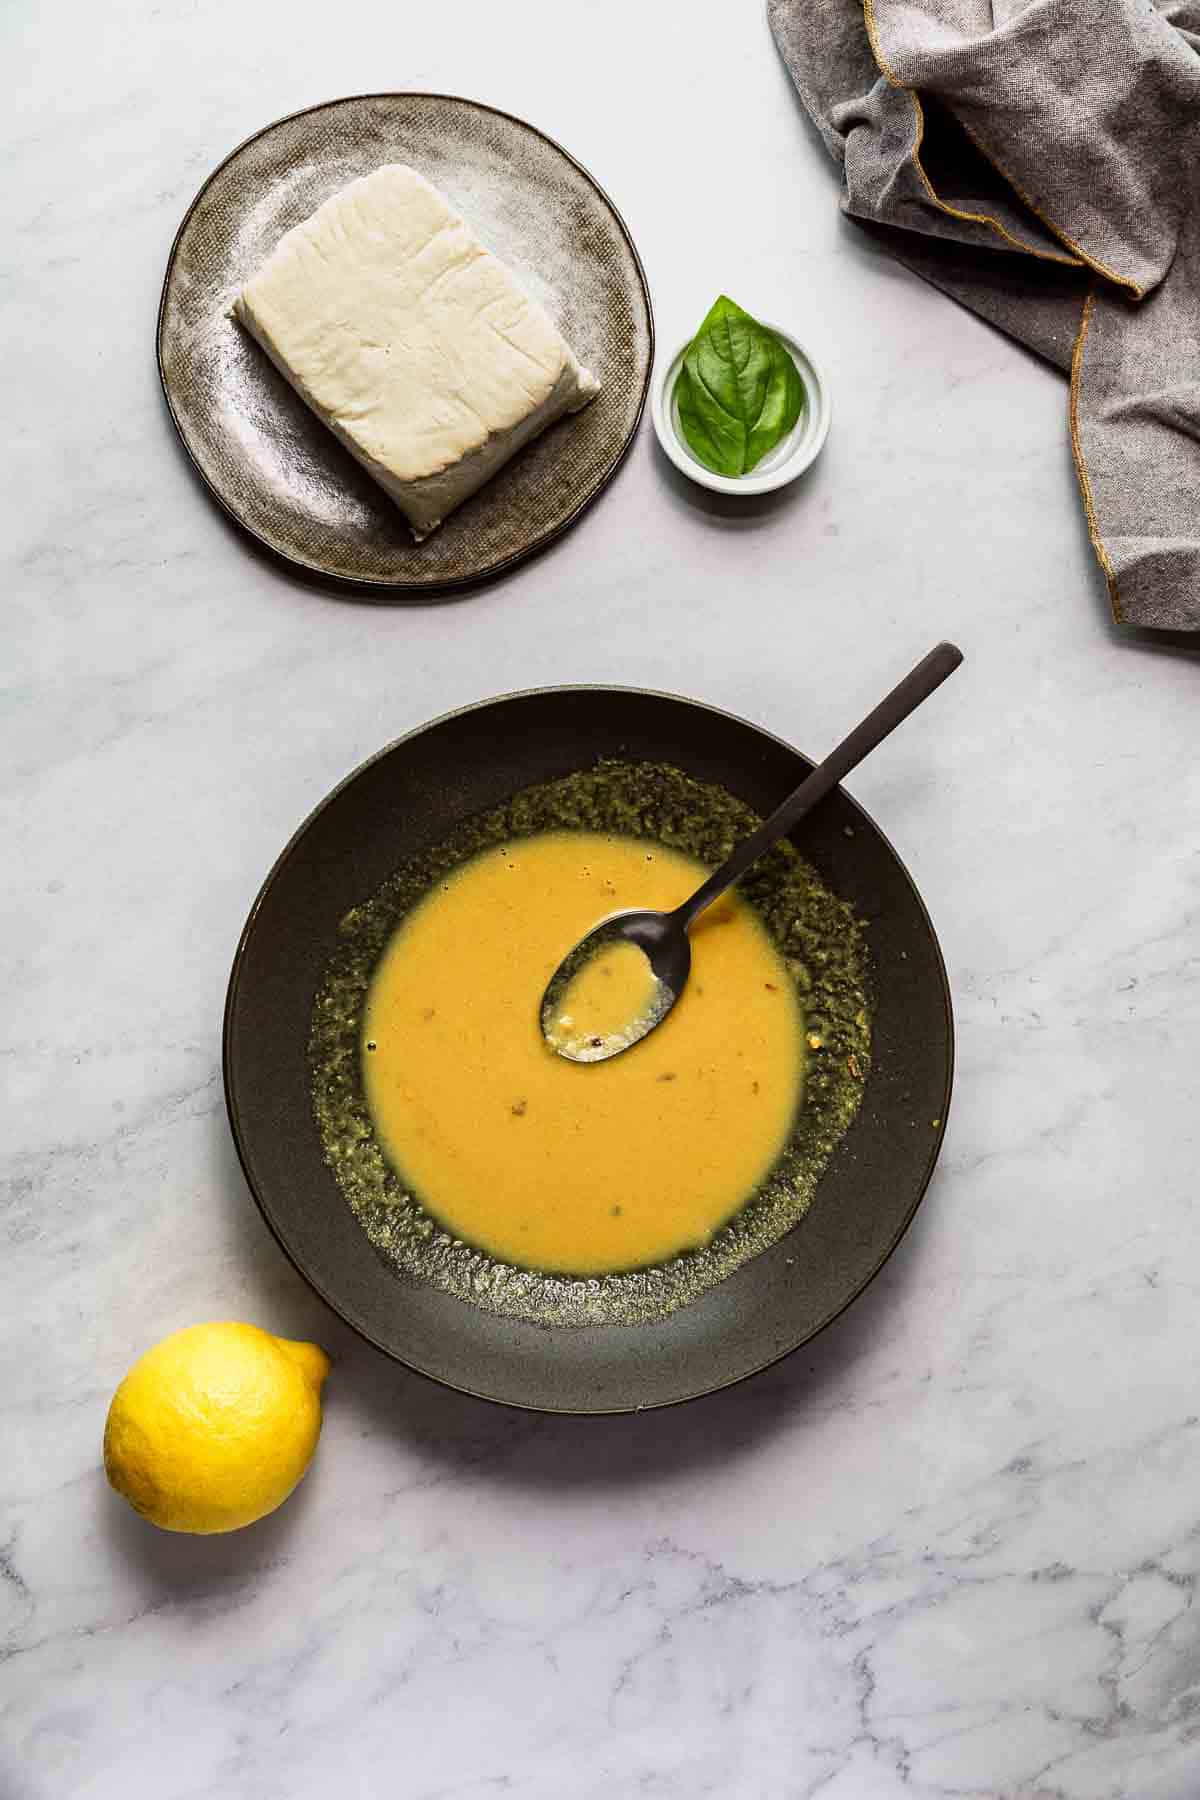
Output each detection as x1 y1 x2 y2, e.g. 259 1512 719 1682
225 688 954 1413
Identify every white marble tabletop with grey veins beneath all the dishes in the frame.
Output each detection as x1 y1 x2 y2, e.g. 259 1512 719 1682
0 0 1200 1800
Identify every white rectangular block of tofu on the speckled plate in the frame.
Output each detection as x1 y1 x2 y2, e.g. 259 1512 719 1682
234 164 599 538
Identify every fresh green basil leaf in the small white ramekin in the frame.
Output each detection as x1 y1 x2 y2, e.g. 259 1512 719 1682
675 293 804 475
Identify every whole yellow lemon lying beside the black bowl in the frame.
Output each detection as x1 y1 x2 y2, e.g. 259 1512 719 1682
104 1323 329 1532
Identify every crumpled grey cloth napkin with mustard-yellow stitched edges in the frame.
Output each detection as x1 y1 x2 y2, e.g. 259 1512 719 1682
768 0 1200 630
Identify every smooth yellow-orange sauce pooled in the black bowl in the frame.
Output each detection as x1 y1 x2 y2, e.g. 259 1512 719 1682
360 830 804 1274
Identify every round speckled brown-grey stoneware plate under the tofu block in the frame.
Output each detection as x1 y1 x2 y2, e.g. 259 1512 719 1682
158 94 653 599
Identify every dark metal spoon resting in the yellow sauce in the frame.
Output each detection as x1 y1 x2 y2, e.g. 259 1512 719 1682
542 644 963 1062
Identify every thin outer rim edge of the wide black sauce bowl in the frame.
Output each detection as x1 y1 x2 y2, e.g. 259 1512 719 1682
221 682 955 1418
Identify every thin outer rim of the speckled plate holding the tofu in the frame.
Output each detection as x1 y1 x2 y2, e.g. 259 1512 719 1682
155 88 657 603
